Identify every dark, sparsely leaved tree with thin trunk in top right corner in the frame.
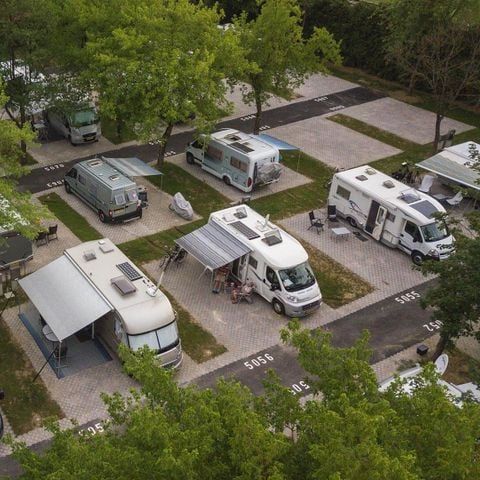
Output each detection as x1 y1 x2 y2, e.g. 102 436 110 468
386 0 480 151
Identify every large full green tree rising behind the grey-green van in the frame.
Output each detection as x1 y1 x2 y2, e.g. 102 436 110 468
83 0 243 166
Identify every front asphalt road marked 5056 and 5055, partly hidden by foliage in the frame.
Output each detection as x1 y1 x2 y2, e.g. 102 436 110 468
195 280 438 395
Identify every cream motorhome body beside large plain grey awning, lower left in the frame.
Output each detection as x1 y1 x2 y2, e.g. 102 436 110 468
64 238 182 368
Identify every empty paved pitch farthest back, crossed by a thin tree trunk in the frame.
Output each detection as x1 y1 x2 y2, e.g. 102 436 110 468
342 97 474 144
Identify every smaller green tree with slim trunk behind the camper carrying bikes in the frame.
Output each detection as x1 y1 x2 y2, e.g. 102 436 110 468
234 0 341 134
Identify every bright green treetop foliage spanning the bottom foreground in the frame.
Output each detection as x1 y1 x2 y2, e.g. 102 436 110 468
7 323 480 480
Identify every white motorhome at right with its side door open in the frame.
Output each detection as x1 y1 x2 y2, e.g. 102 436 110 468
328 165 454 265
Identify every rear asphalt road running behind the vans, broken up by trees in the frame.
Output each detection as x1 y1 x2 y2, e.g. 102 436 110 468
18 87 383 193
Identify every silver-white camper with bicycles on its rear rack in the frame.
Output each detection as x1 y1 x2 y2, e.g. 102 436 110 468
185 128 282 192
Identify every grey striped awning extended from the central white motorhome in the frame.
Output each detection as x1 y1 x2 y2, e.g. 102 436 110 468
175 222 252 270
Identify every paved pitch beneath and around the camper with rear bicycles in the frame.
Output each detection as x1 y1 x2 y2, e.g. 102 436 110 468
167 154 312 200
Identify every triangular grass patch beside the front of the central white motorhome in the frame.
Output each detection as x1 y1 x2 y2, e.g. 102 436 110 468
301 240 374 308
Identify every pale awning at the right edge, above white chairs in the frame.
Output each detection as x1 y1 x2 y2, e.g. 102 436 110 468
417 142 480 190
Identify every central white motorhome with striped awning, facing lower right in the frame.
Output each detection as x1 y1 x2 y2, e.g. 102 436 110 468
209 205 322 317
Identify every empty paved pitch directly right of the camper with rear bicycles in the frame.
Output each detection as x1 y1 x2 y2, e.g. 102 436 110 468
268 115 401 169
